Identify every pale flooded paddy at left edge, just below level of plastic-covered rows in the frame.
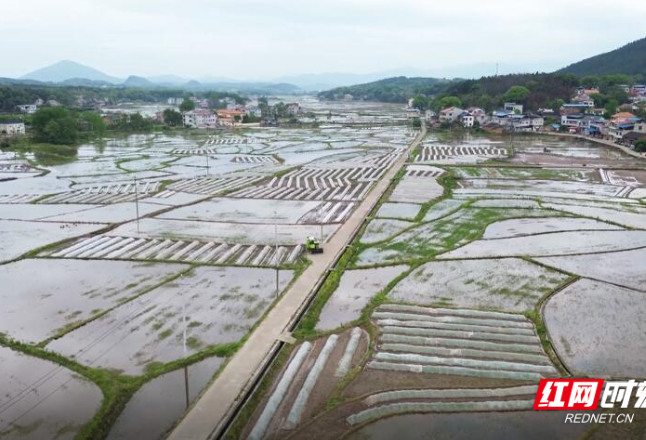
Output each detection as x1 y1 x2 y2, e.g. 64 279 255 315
0 259 187 343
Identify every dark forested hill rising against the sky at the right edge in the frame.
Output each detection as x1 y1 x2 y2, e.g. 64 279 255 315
558 38 646 76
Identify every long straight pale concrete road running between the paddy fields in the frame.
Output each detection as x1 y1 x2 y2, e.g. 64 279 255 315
168 125 426 440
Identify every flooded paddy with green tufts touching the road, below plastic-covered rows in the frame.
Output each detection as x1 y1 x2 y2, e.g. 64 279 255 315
47 267 293 375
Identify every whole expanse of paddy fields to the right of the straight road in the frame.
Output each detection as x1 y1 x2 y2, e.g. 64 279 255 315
237 133 646 440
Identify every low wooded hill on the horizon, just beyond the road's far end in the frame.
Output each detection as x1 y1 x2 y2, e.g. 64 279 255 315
319 76 452 102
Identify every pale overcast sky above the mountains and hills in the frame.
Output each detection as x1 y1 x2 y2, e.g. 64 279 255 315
0 0 646 79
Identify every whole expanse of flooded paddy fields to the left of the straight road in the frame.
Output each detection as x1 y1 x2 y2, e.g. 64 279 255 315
0 115 417 440
